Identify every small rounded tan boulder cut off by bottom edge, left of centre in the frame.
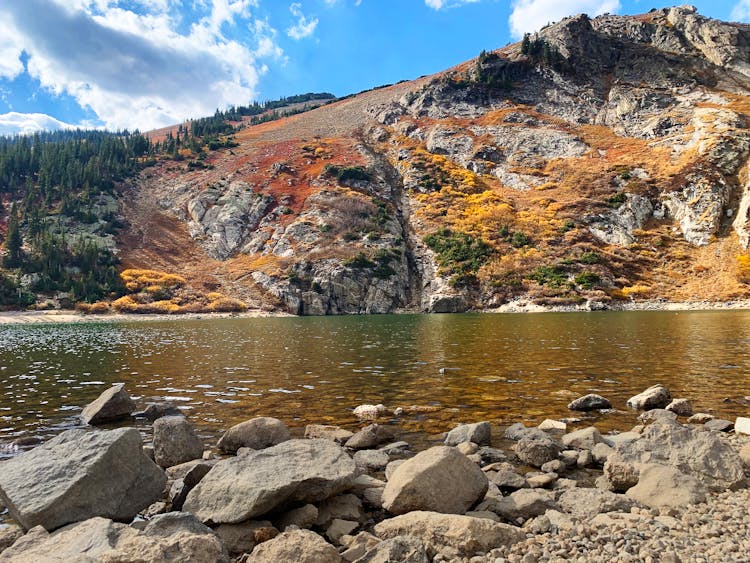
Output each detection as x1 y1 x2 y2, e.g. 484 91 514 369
245 530 341 563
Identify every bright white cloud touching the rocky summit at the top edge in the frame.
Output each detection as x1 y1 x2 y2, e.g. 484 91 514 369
512 0 624 39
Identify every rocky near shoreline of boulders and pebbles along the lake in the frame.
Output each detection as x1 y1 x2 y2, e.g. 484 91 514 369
0 385 750 563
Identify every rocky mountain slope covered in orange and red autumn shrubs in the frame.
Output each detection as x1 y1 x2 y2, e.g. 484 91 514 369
118 6 750 314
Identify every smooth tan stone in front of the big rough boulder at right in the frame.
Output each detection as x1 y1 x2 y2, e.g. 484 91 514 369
626 463 707 508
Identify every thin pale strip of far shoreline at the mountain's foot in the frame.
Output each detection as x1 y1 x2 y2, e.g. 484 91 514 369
0 299 750 325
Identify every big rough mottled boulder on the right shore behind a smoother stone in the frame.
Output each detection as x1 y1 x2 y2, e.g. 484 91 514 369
604 420 745 491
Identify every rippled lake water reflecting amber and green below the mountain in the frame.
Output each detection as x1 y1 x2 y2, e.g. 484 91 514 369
0 311 750 452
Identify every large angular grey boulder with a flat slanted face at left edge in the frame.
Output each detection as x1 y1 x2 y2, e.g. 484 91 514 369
0 428 167 531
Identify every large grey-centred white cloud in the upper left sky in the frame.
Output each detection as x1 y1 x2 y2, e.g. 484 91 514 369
0 0 283 130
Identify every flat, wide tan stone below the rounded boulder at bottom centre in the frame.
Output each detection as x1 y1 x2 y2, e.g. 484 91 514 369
374 511 526 558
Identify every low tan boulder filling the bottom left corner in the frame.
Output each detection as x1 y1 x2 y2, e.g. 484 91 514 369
0 513 229 563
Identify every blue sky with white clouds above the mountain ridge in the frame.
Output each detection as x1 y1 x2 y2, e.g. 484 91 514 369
0 0 750 135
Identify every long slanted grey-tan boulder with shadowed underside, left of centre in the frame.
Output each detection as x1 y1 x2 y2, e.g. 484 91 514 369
184 440 357 524
